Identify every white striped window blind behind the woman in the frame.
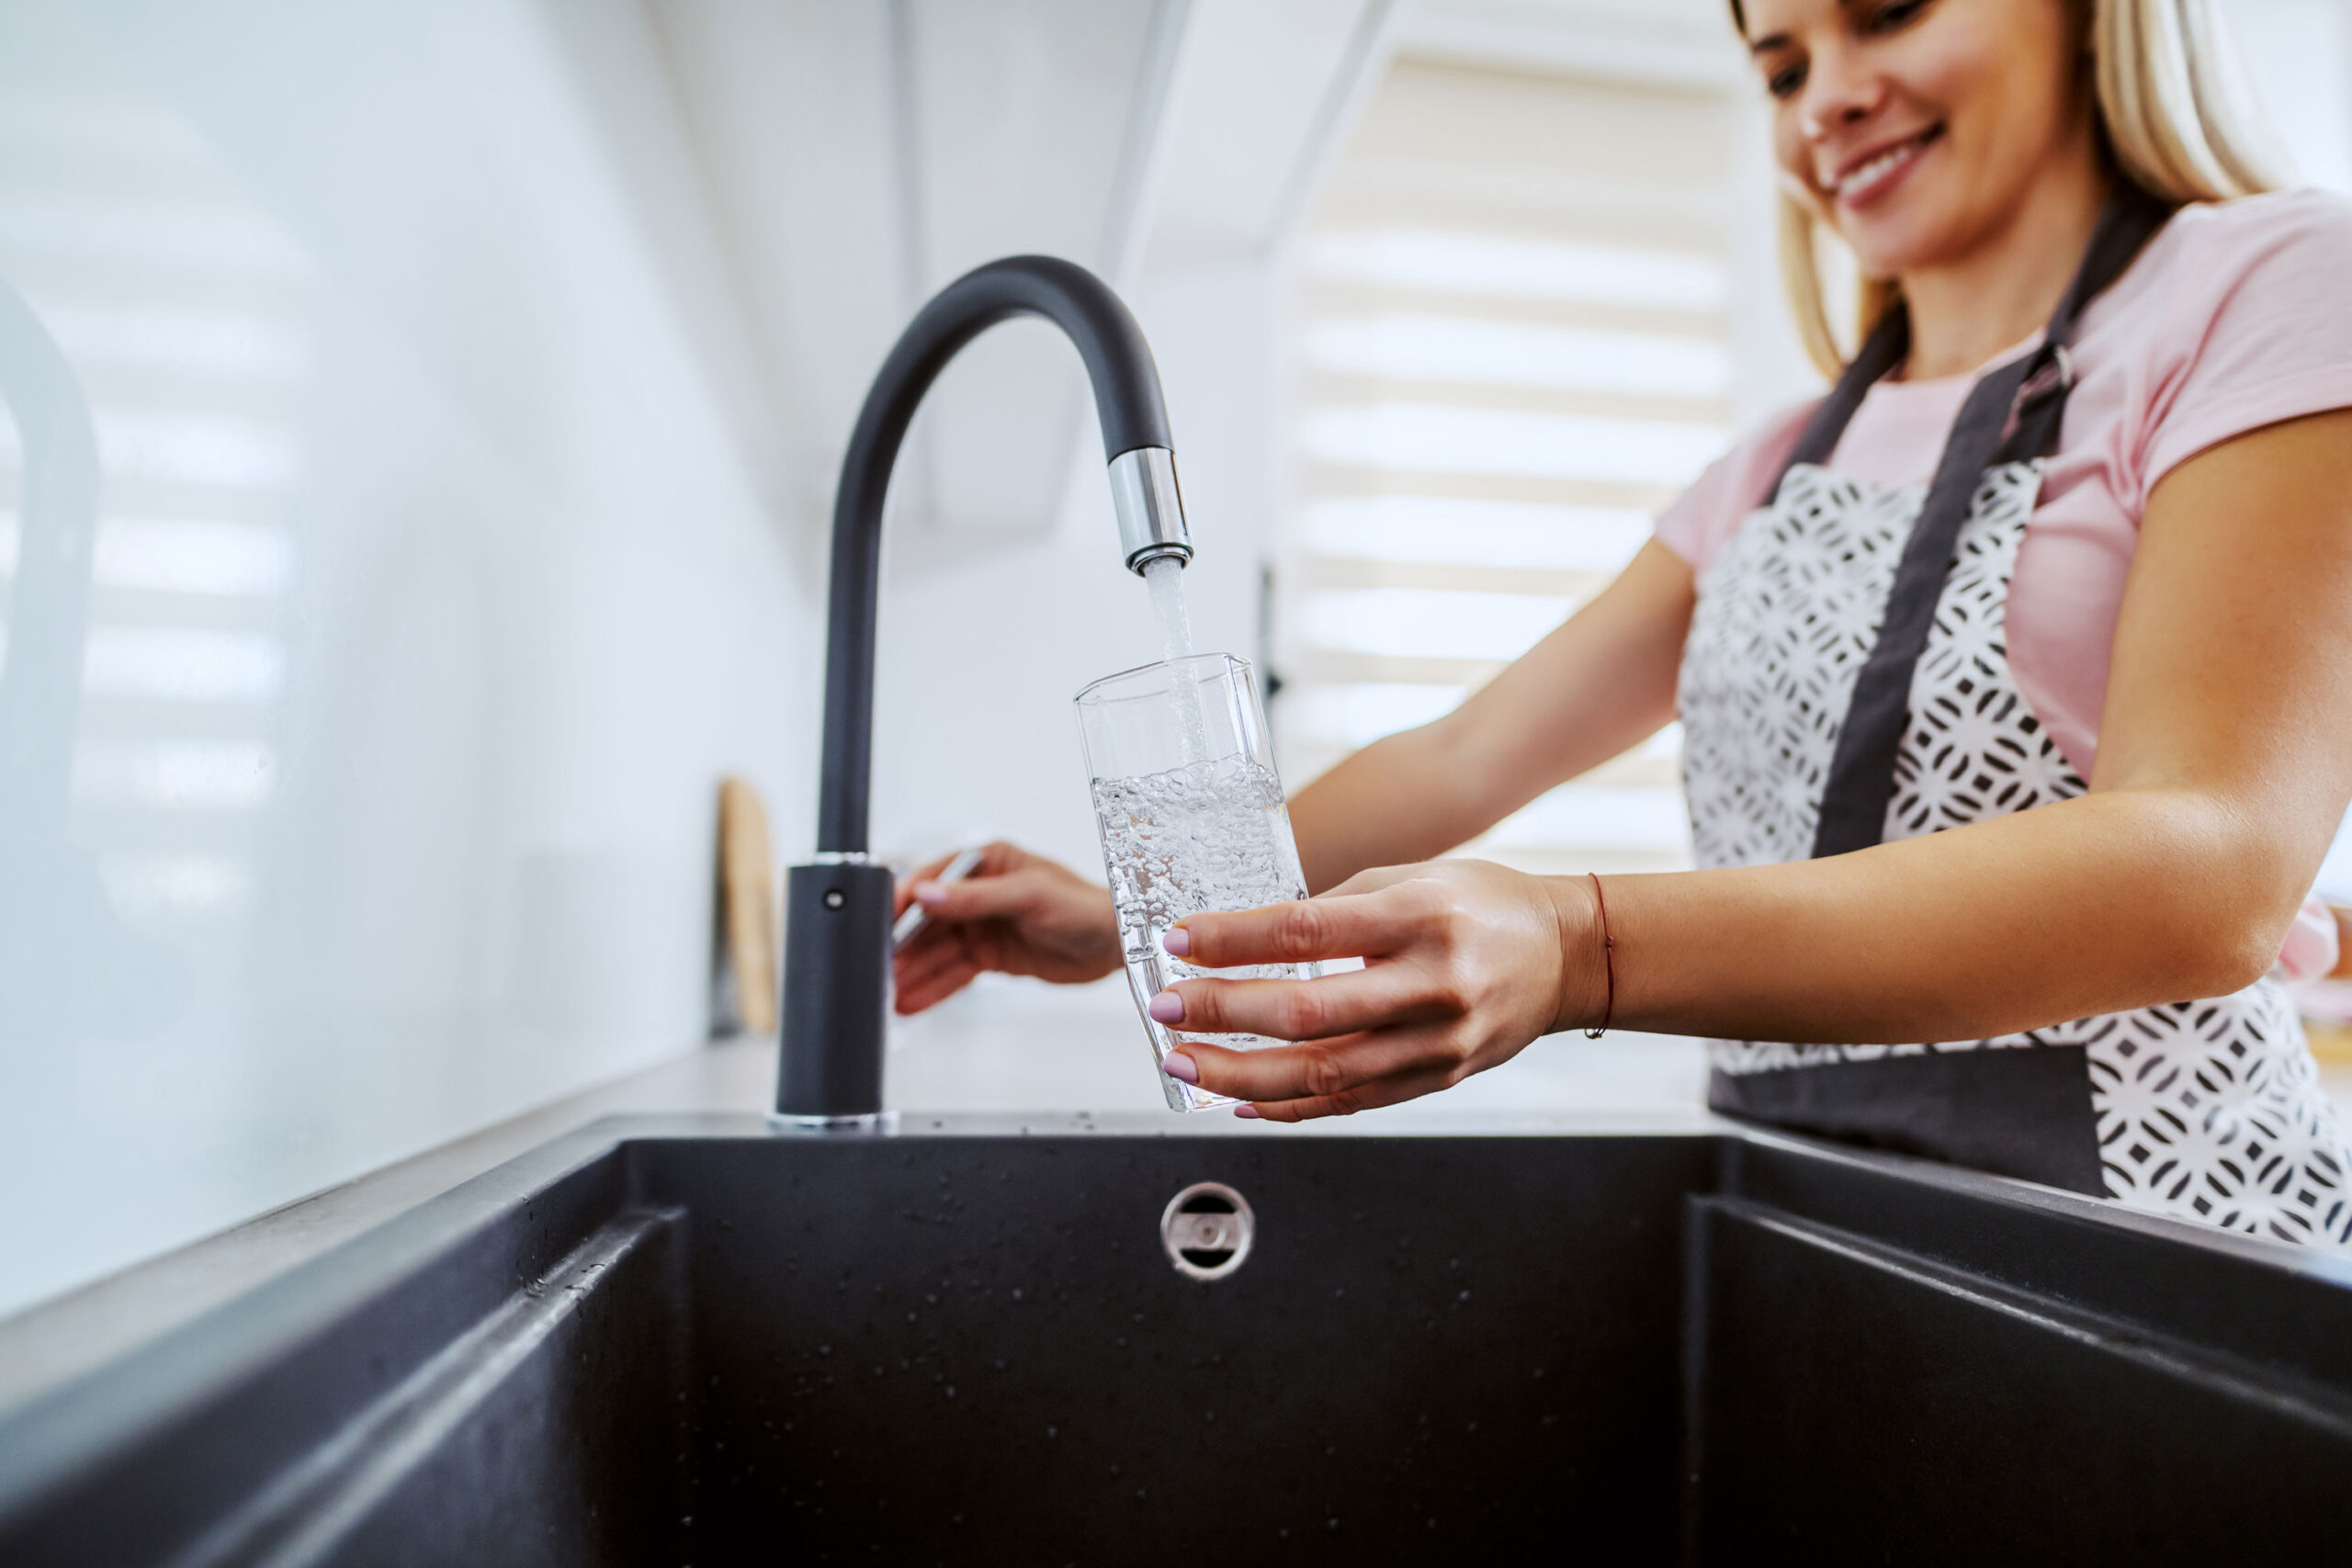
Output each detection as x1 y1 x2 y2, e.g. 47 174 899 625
1270 59 1731 870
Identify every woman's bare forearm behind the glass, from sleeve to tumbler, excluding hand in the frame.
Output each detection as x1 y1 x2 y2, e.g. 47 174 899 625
1291 541 1693 894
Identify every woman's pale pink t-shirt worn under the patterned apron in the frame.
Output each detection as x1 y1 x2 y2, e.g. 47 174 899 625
1658 190 2352 980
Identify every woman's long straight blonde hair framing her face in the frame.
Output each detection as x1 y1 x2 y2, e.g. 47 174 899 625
1731 0 2290 378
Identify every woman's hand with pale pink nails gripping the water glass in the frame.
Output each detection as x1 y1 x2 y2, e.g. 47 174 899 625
1150 861 1606 1122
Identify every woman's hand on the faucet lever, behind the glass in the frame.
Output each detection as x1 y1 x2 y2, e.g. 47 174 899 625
891 841 1120 1013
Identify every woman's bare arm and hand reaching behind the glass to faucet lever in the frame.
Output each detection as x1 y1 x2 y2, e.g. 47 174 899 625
894 541 1693 1013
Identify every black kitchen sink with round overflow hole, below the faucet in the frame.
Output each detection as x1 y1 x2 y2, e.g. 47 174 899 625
0 1117 2352 1565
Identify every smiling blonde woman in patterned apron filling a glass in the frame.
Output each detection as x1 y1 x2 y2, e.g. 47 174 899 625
899 0 2352 1246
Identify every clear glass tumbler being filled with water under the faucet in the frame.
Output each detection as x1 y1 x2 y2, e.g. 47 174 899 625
1077 653 1322 1110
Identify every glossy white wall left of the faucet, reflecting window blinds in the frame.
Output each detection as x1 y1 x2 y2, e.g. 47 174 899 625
0 0 819 1309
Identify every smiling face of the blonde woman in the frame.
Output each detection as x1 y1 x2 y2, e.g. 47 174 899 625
1746 0 2098 277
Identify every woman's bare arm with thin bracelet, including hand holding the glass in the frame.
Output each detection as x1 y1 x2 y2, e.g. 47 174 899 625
1155 412 2352 1119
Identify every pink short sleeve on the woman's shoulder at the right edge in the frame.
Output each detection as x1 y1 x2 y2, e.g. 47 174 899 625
2133 190 2352 510
